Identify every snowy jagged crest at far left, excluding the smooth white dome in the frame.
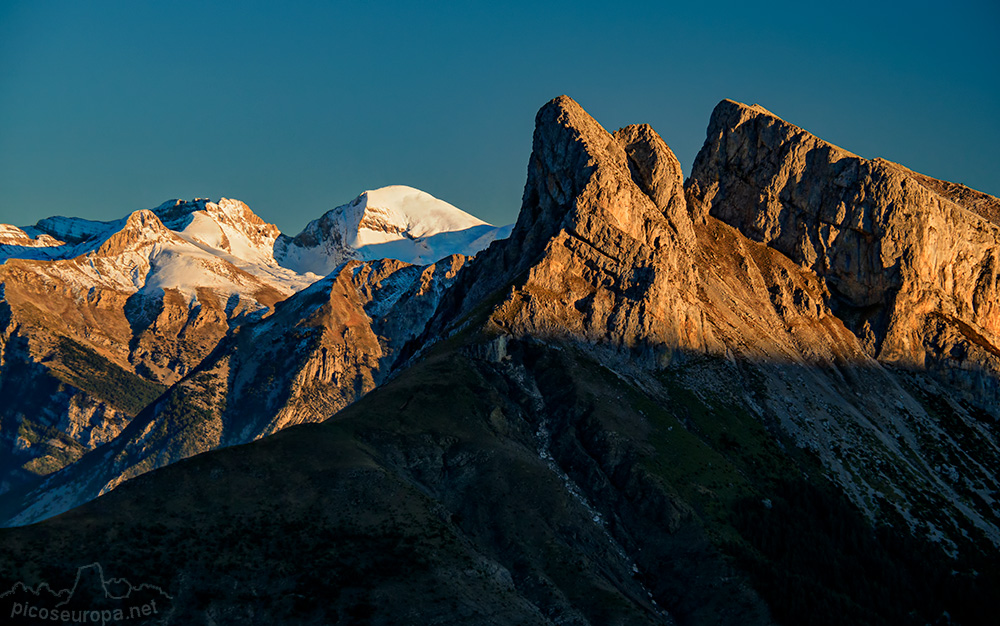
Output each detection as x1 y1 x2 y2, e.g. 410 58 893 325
0 198 308 303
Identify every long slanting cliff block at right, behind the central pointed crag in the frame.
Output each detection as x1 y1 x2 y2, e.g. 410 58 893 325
688 100 1000 398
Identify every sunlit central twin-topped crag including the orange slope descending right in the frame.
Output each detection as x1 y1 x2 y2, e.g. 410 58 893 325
446 96 865 366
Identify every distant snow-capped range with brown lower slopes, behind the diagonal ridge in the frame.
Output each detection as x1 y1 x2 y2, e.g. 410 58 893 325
0 186 510 493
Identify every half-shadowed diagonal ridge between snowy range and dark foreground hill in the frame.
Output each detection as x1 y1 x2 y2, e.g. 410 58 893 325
0 257 465 524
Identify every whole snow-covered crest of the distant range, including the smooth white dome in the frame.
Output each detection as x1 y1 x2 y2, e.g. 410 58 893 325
0 185 510 299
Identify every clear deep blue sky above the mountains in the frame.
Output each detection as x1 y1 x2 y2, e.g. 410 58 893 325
0 0 1000 234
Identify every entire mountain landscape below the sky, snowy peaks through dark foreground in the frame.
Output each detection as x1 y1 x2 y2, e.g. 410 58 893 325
0 96 1000 625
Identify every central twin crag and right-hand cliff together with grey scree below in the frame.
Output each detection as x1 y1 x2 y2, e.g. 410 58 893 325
432 97 1000 556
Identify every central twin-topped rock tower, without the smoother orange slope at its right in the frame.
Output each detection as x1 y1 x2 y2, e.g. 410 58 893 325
430 96 711 361
